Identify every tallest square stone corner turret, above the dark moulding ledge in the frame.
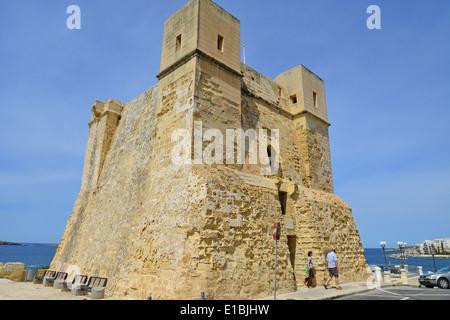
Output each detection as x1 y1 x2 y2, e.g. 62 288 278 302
160 0 241 72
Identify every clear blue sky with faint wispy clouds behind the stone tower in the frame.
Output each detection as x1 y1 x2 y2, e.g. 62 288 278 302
0 0 450 247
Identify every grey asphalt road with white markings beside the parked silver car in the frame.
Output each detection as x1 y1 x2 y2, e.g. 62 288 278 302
335 286 450 300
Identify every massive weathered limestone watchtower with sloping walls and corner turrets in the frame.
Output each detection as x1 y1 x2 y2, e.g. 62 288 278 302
51 0 366 299
